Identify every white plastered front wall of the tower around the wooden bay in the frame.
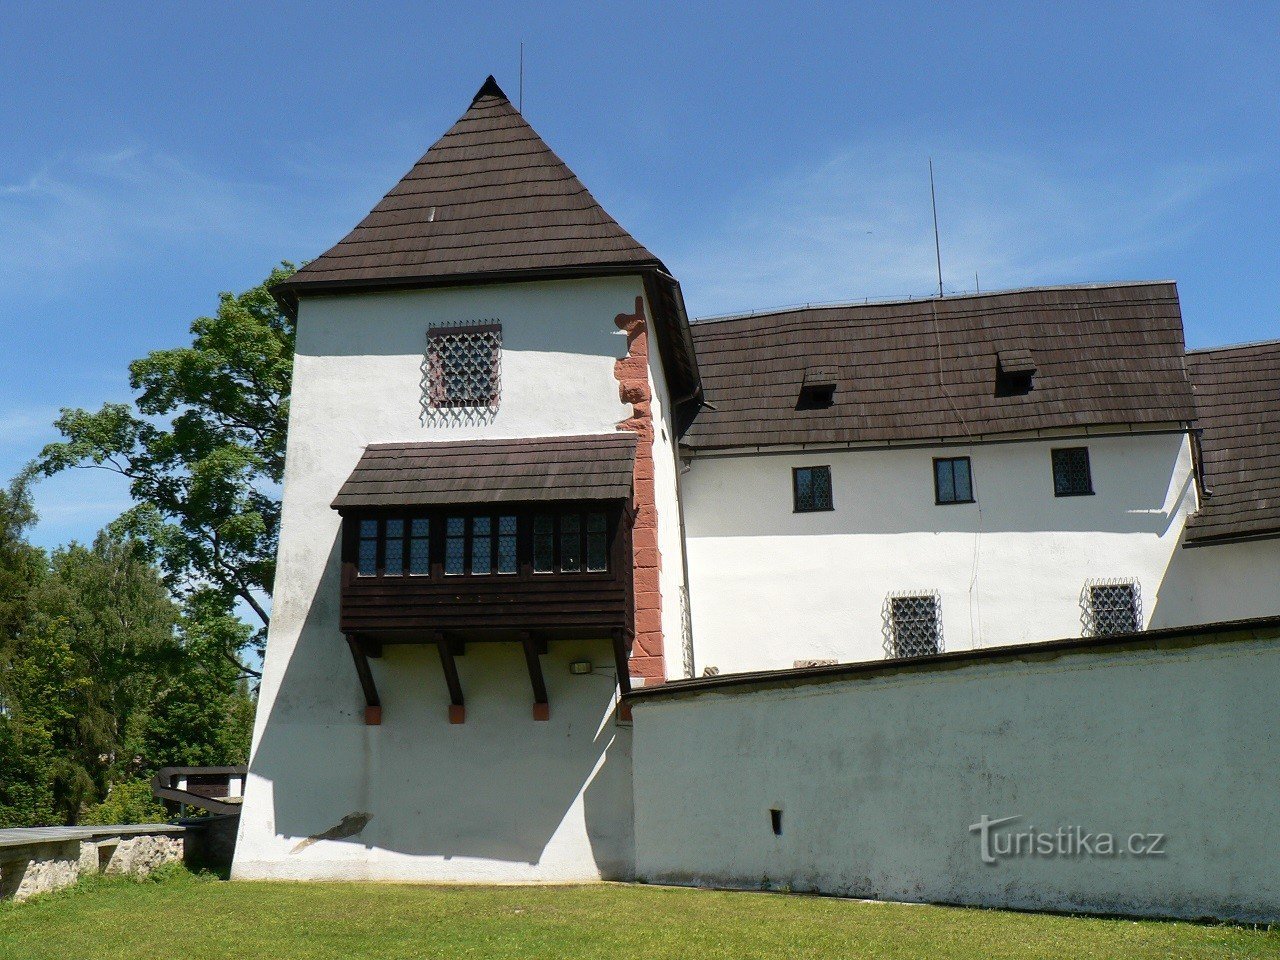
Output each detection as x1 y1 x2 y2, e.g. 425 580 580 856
233 278 668 882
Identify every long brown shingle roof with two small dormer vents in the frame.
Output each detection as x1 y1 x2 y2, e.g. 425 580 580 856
684 282 1196 449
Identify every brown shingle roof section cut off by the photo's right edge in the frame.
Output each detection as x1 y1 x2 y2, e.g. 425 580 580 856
1187 340 1280 543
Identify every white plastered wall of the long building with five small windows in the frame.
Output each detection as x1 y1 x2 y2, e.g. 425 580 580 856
682 433 1196 673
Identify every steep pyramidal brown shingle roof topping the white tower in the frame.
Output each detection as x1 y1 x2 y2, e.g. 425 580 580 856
283 77 662 294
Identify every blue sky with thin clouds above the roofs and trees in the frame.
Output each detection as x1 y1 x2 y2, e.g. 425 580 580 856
0 3 1280 545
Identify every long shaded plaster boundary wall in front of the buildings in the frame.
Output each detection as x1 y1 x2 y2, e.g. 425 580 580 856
626 618 1280 922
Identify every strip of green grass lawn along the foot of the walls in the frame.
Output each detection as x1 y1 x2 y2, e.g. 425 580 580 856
0 872 1280 960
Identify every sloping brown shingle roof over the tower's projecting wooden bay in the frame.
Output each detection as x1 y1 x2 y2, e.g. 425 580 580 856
332 433 636 509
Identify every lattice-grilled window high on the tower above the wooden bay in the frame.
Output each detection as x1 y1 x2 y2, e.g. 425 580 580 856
421 321 502 425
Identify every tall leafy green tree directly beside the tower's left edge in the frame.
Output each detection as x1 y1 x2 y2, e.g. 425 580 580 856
38 264 294 675
